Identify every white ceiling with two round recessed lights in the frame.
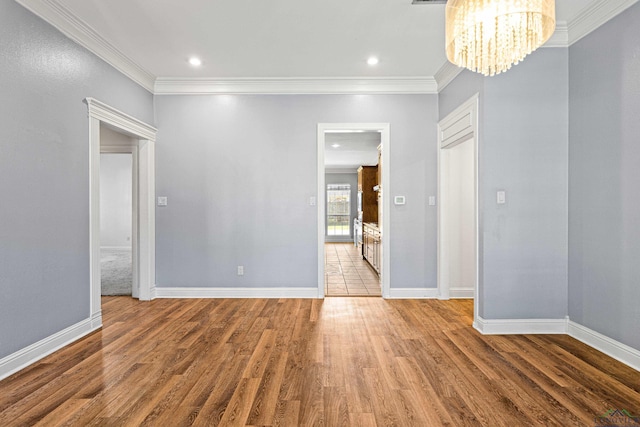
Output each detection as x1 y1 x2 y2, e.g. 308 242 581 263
26 0 604 85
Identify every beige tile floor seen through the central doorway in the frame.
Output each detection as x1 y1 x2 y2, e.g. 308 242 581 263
324 243 382 297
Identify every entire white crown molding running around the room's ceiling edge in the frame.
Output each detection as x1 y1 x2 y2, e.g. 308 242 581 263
16 0 639 95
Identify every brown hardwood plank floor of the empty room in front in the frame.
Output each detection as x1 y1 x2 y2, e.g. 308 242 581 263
0 297 640 426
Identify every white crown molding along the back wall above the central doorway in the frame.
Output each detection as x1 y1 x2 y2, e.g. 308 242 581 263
154 77 438 95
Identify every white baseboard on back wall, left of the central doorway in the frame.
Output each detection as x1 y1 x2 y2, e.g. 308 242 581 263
154 287 318 298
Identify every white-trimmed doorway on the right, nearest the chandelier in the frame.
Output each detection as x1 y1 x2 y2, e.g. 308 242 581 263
438 95 479 324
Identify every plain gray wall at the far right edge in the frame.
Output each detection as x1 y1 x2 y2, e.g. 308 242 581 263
569 4 640 349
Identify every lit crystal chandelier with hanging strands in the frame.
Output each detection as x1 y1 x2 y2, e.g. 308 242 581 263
446 0 556 76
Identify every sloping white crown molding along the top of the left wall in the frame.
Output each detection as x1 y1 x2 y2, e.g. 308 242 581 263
16 0 155 92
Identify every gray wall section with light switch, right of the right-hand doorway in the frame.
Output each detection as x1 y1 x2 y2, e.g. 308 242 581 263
440 49 568 319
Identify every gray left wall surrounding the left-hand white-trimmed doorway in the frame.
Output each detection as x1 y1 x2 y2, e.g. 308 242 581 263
0 1 153 358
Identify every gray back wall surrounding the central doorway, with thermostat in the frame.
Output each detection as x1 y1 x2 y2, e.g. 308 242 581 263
155 95 437 288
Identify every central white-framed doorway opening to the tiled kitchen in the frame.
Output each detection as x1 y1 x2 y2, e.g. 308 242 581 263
317 123 389 298
